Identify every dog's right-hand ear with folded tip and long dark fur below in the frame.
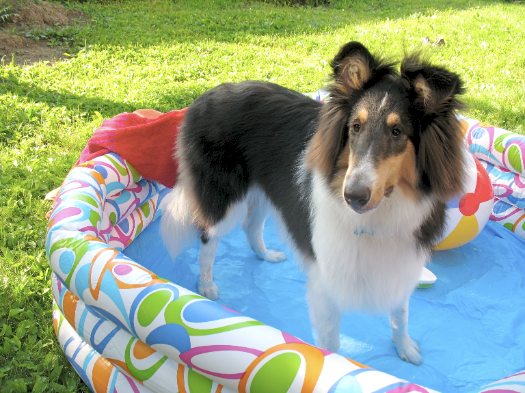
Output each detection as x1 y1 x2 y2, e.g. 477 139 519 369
401 55 465 202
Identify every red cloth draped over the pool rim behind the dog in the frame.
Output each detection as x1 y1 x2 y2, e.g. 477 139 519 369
78 108 187 187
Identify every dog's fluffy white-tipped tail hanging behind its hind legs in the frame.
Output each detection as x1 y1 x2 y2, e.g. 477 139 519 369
160 184 198 258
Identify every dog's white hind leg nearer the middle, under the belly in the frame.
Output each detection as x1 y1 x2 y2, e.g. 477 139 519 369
242 195 286 262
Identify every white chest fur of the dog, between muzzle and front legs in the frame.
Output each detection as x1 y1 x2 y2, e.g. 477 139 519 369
310 173 432 311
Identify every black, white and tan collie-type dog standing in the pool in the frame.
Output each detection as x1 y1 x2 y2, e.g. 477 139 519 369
161 42 464 364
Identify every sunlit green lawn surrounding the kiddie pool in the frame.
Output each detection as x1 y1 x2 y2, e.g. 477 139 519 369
0 0 525 392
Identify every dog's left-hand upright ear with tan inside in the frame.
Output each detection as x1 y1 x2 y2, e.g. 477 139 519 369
330 41 379 93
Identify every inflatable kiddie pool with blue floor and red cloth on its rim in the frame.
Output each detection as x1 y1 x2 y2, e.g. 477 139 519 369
46 102 525 393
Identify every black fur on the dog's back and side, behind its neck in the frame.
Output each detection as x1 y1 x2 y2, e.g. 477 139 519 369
179 81 322 255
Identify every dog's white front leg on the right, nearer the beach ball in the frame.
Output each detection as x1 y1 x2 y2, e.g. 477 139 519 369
390 300 423 364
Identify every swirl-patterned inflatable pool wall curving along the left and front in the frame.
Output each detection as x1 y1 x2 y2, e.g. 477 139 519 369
46 154 428 393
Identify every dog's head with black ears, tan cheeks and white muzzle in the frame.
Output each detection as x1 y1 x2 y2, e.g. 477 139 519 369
307 42 463 213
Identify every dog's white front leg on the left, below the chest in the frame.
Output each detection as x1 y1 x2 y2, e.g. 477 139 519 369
308 266 341 352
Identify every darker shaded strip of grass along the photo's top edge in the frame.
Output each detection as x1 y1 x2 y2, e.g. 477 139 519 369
72 0 508 45
